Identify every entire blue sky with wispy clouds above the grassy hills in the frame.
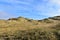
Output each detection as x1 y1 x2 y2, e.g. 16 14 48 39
0 0 60 19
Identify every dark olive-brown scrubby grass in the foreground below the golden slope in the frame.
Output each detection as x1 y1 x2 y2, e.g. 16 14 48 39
0 28 57 40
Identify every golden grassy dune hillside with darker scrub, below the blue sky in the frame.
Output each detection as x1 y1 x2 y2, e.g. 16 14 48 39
0 16 60 40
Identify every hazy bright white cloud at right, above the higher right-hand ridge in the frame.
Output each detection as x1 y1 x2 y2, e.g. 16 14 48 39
35 0 60 16
